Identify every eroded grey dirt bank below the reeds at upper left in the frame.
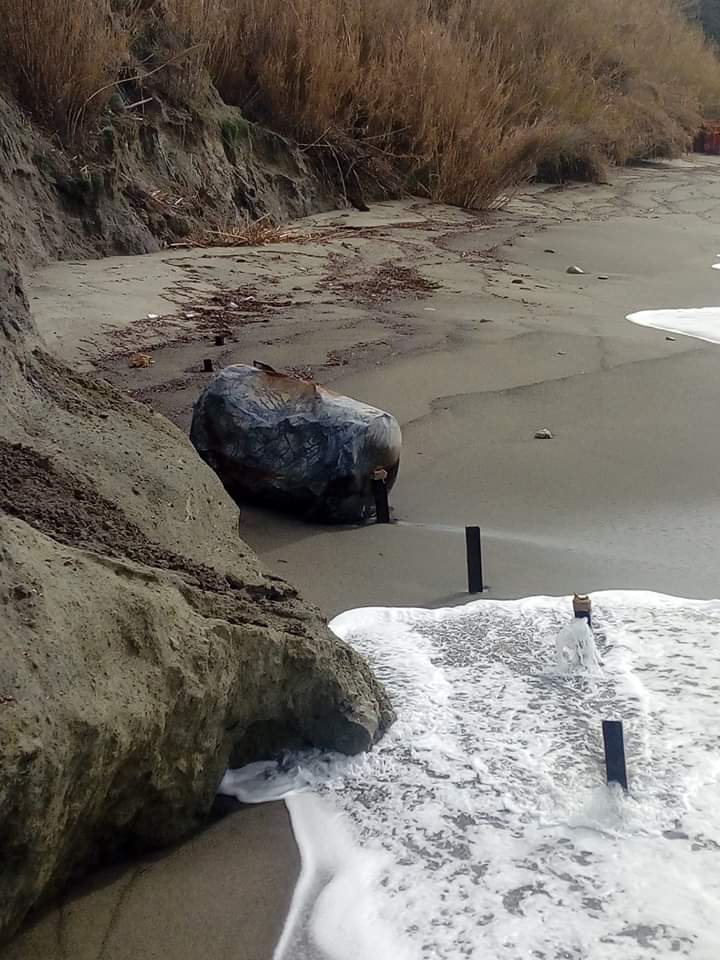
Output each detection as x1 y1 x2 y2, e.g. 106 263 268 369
0 89 339 265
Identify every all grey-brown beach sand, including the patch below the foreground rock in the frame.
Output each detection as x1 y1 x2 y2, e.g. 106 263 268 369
9 157 720 960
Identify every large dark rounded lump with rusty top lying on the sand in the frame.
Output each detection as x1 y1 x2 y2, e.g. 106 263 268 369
190 364 402 523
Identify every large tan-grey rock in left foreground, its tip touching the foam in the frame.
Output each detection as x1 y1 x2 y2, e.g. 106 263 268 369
0 266 392 939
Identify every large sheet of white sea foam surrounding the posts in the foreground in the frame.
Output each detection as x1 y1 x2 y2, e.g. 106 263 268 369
222 592 720 960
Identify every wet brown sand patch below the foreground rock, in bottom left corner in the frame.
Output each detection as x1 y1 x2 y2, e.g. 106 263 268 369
0 803 300 960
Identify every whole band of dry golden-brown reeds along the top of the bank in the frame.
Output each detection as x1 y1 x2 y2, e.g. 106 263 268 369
0 0 720 207
